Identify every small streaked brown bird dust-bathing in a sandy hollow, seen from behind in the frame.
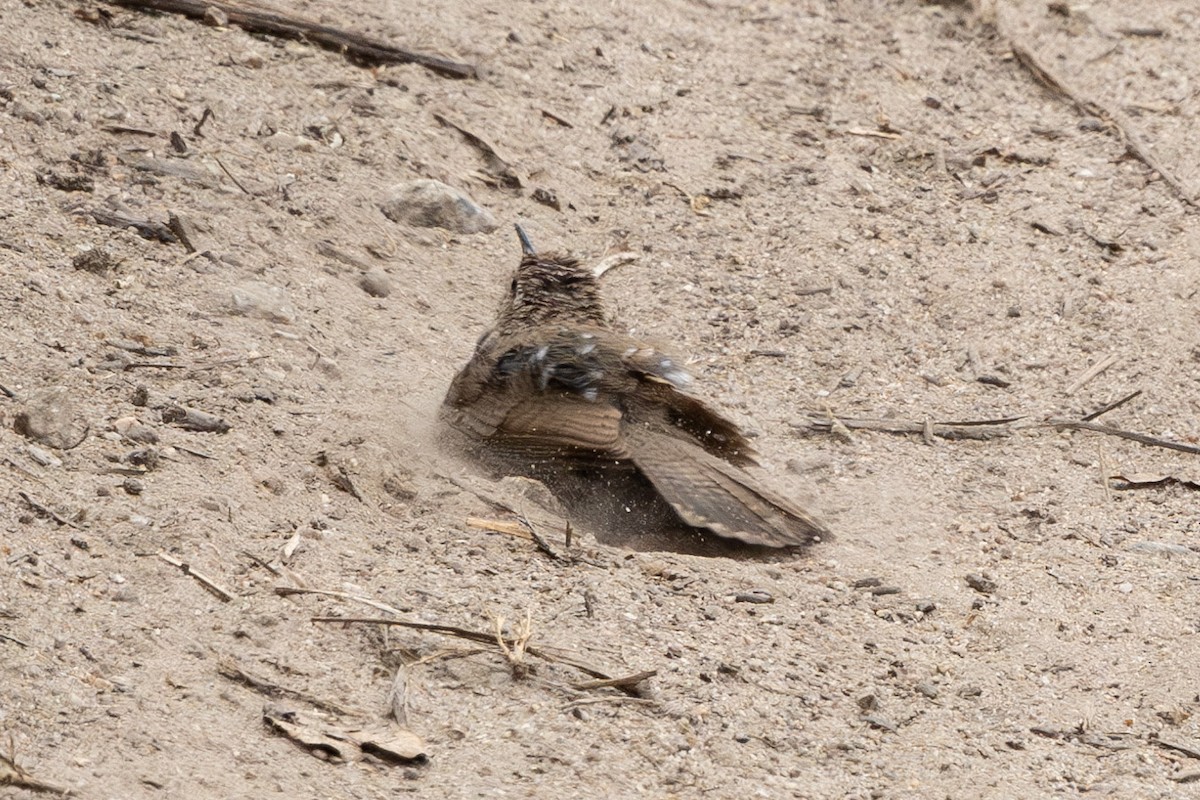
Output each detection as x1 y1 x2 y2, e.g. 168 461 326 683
443 225 828 547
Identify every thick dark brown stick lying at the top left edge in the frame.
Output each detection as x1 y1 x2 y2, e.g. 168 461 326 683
109 0 476 78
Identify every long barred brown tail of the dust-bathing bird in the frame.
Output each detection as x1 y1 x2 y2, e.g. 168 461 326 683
625 426 829 547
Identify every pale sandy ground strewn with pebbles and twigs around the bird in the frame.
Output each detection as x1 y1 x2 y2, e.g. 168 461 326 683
0 0 1200 798
